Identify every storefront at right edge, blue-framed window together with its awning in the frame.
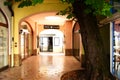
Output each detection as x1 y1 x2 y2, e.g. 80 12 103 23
100 12 120 79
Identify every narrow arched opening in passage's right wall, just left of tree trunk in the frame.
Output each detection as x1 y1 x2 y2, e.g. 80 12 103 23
72 22 84 60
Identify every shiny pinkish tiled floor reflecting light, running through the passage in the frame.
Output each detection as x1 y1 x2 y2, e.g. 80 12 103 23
0 53 81 80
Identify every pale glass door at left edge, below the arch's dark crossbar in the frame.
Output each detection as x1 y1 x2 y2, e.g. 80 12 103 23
0 26 8 68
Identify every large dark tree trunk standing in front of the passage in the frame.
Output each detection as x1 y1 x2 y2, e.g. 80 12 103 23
73 0 114 80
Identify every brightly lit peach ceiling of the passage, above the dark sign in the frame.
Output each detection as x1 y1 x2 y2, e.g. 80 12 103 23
26 12 67 25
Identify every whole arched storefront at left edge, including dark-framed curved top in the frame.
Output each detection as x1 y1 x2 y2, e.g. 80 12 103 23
0 8 8 69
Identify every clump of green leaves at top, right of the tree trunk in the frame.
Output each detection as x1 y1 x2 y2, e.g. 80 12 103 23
85 0 111 16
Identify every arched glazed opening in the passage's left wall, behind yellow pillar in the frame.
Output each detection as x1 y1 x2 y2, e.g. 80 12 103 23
19 21 33 59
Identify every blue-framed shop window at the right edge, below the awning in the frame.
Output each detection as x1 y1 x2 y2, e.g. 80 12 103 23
111 20 120 79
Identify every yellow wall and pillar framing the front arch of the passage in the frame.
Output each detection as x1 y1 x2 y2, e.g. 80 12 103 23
13 0 67 54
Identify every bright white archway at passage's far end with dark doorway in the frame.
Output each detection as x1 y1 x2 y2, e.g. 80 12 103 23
39 29 64 53
